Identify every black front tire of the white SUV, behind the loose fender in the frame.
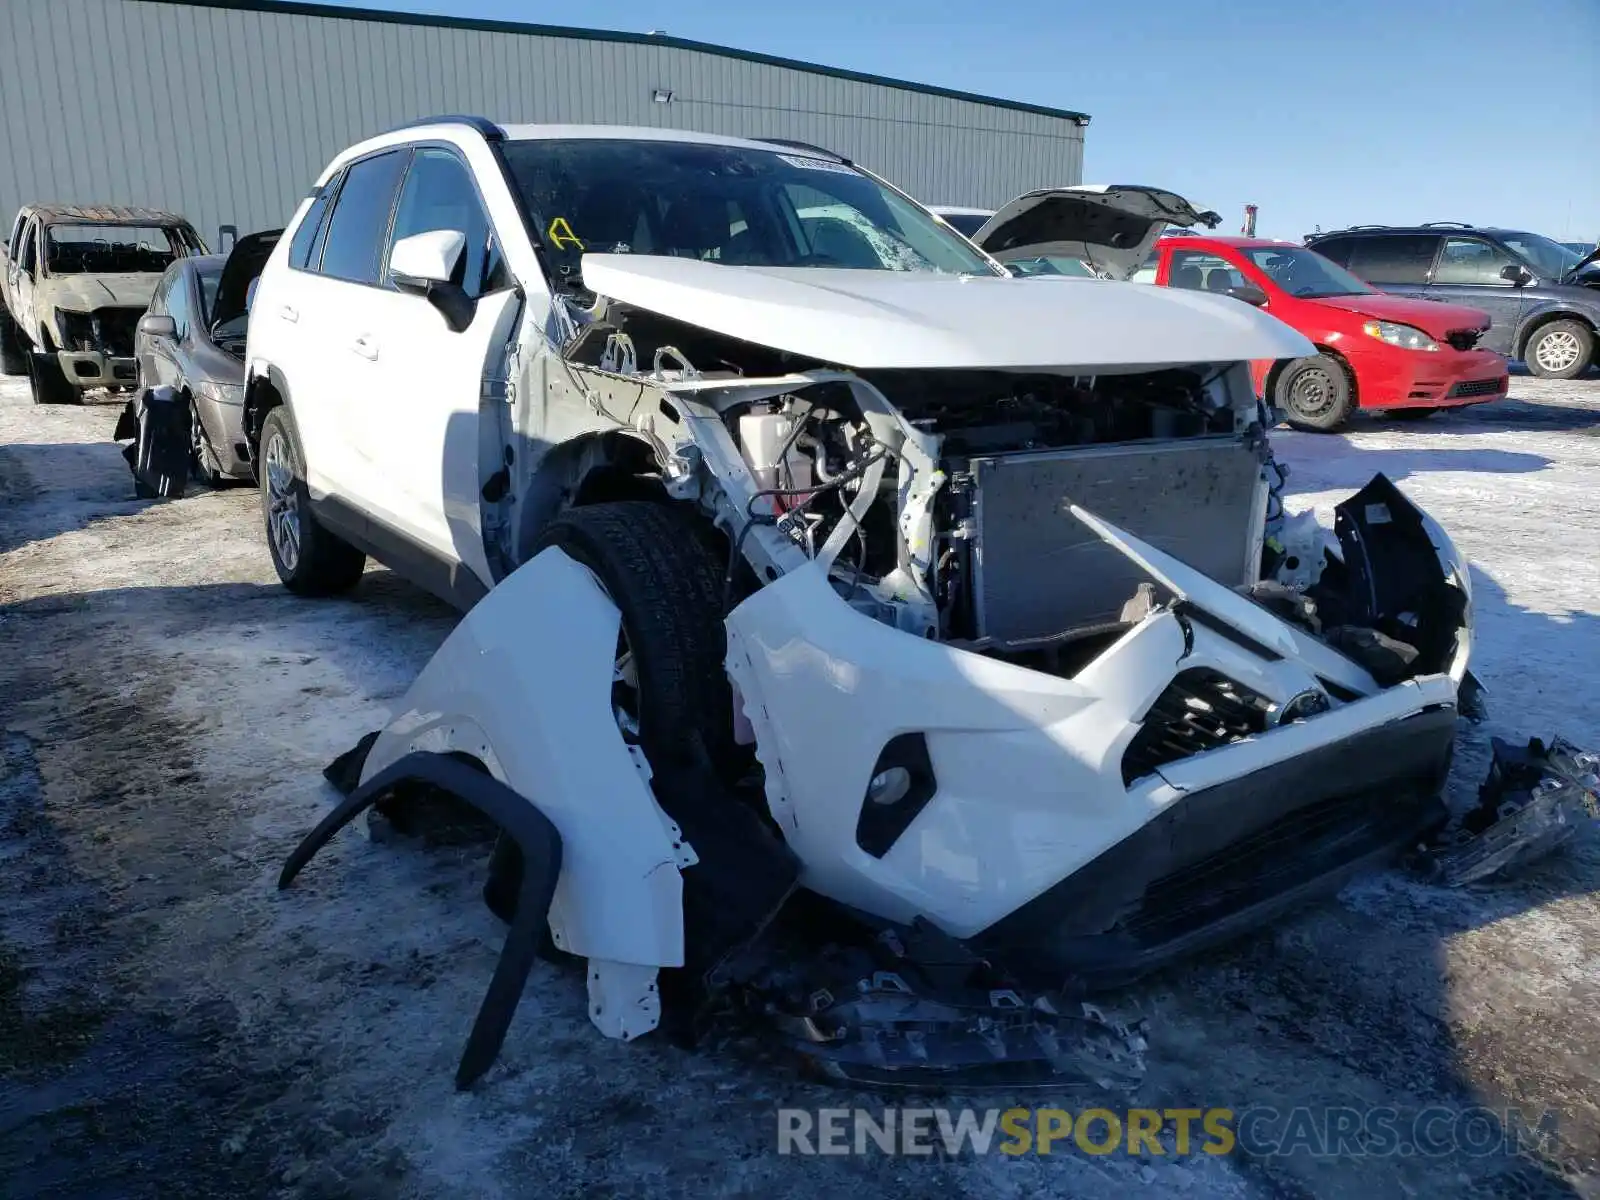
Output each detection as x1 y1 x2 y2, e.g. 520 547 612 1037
534 501 739 778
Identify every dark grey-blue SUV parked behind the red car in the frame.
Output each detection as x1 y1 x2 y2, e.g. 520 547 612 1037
1306 221 1600 379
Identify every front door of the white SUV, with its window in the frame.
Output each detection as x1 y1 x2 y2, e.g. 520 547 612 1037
350 146 520 587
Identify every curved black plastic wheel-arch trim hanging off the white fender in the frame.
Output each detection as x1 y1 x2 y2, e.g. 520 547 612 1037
278 747 562 1090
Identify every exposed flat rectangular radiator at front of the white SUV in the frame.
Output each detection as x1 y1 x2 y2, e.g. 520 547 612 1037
971 437 1266 643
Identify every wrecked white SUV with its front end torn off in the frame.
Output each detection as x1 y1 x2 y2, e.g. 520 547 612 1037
262 118 1587 1083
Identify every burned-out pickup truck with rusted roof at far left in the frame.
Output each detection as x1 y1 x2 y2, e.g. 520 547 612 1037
0 205 205 405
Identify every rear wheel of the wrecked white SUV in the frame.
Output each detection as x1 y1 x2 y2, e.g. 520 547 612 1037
259 405 366 595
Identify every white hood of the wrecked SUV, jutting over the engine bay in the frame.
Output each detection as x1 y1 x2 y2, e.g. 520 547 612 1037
582 254 1315 370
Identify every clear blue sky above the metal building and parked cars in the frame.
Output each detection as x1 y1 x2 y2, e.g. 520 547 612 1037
294 0 1600 240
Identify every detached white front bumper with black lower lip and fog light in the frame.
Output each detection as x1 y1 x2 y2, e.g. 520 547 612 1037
728 480 1470 982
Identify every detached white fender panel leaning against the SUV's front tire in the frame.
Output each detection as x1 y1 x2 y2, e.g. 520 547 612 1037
362 549 691 966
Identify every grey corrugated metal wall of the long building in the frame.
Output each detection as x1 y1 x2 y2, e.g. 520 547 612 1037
0 0 1083 238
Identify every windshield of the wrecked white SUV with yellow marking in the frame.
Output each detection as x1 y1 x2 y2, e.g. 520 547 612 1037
502 138 995 288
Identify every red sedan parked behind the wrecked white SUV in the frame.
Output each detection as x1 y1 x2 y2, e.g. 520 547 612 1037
1139 235 1509 430
